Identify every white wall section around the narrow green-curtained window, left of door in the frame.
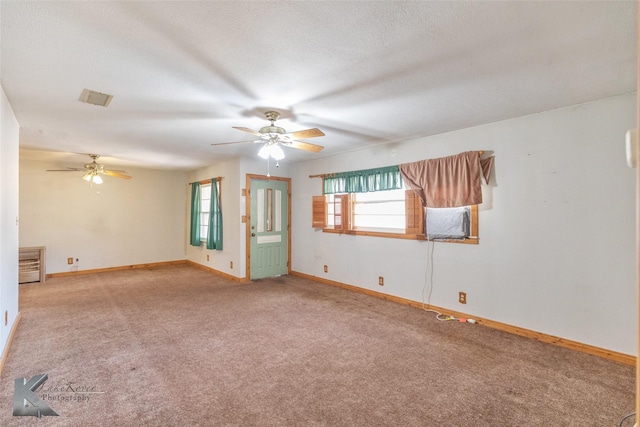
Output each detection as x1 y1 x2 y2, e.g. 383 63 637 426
185 155 289 279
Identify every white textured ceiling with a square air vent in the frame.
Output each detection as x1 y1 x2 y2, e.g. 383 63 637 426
0 1 637 170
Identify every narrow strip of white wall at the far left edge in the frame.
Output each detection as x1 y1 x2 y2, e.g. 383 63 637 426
0 87 19 362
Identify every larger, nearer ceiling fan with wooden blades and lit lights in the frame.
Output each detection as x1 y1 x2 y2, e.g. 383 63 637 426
211 111 324 160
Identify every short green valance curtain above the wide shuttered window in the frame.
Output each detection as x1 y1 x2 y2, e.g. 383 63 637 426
324 165 402 194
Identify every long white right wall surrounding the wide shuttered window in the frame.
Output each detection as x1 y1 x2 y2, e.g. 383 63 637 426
292 94 637 355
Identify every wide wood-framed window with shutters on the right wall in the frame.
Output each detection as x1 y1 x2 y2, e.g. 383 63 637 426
312 189 478 243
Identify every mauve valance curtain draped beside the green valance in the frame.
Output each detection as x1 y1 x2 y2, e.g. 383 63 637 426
400 151 493 208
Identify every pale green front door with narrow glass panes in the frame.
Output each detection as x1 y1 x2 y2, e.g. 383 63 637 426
249 179 289 280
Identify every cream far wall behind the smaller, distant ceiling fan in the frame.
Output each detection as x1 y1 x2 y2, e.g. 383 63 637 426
20 159 186 274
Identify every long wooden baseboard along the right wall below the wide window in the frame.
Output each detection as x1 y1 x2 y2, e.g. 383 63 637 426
291 271 637 366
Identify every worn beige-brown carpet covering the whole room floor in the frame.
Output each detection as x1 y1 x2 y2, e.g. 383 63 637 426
0 266 635 427
